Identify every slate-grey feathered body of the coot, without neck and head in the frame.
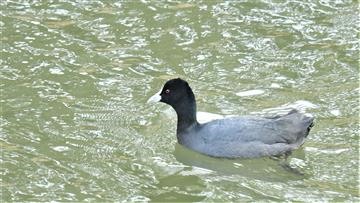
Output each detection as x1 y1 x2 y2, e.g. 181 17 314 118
178 110 313 158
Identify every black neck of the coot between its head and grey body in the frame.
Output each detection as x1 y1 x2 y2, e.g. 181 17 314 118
175 100 198 135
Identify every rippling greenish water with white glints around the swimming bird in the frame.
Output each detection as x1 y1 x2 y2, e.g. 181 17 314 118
0 0 360 202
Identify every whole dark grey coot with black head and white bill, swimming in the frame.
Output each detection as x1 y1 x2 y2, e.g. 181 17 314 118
148 78 314 158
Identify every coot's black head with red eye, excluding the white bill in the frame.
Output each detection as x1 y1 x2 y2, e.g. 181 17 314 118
160 78 195 108
